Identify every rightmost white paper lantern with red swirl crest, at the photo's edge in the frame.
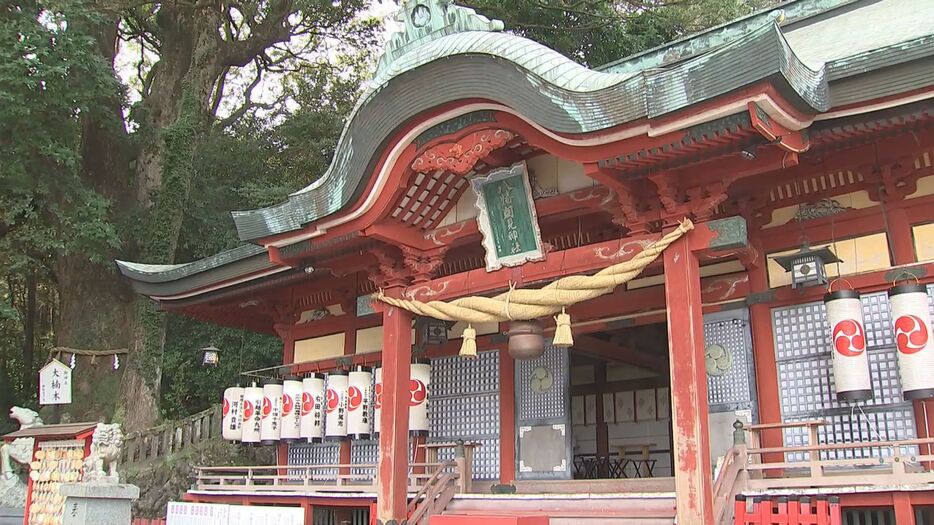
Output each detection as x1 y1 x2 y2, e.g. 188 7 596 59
889 284 934 400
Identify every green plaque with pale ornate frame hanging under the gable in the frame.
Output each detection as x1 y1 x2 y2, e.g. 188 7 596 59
471 162 545 271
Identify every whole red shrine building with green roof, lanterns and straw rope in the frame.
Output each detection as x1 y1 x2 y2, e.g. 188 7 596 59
118 0 934 525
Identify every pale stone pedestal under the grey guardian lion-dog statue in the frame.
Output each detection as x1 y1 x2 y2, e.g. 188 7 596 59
59 483 139 525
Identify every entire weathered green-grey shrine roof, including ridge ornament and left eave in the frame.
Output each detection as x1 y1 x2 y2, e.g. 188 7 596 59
118 0 934 294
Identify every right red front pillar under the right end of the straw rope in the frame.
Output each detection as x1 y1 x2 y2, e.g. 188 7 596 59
665 234 713 525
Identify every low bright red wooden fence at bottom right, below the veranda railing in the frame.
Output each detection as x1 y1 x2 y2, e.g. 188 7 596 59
734 495 842 525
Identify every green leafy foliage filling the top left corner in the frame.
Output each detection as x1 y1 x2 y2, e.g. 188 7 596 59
0 1 123 264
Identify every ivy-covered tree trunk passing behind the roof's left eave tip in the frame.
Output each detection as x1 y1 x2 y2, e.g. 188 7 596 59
118 12 228 430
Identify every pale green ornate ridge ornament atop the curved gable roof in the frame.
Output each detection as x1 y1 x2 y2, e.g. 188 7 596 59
376 0 505 76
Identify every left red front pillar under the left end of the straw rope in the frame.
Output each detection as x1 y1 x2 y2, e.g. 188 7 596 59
376 296 412 524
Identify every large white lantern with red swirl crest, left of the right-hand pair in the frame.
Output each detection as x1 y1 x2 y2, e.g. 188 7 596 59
824 290 872 401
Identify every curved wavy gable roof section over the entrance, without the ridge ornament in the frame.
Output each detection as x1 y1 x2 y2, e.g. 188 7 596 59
233 17 828 241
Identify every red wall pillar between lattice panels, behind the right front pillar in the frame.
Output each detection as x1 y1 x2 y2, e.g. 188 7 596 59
749 239 784 463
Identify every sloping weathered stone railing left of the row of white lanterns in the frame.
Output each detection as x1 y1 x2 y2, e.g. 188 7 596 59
122 405 221 464
